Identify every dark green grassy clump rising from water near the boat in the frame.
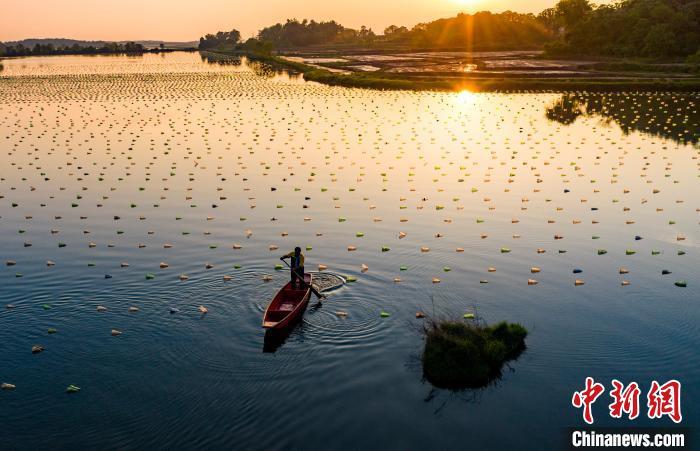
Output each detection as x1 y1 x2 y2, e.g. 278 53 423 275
422 321 527 389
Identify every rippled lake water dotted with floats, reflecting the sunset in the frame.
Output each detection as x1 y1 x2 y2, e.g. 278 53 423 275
0 53 700 450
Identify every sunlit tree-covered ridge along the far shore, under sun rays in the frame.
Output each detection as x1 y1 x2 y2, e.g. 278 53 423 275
199 0 700 62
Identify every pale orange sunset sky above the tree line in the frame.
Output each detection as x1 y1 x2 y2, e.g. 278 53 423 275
0 0 612 41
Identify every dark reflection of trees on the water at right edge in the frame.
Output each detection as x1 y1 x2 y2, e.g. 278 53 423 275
545 93 700 144
